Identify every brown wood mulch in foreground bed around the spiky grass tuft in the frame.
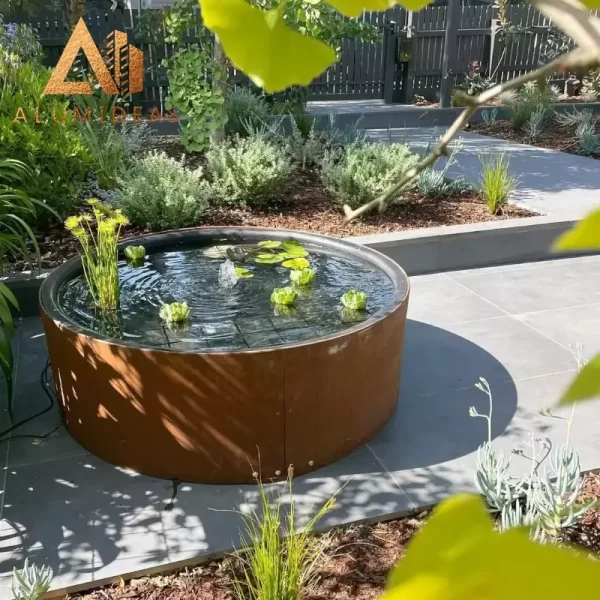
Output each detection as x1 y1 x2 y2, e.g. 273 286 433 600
71 473 600 600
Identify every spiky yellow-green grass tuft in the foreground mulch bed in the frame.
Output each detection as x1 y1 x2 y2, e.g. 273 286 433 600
233 467 335 600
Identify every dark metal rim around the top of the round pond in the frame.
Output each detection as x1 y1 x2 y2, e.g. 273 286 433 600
40 227 410 354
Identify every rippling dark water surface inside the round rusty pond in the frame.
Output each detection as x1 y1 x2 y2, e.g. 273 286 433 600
59 241 394 351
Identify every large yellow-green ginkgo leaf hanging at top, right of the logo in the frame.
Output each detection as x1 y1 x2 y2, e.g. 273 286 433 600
200 0 336 93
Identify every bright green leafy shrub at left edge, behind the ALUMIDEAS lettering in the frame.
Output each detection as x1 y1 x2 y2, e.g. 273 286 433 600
0 64 92 225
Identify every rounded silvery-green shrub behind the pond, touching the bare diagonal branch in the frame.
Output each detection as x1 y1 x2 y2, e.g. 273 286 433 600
321 142 419 208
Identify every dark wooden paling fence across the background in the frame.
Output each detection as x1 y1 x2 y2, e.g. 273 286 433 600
12 4 580 105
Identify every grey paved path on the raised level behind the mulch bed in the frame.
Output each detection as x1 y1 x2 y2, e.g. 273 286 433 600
369 127 600 219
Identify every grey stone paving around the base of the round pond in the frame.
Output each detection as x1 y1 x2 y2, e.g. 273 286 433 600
0 257 600 597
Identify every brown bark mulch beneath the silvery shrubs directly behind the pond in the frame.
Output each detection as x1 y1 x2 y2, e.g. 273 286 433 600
22 171 536 270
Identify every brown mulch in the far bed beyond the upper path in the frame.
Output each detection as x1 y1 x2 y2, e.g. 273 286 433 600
468 118 600 158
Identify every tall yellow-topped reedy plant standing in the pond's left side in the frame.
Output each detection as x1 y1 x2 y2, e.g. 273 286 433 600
65 198 129 312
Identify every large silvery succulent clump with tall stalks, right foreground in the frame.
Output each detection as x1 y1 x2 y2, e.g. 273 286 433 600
469 347 595 543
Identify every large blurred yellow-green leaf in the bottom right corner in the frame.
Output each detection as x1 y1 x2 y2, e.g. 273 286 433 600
382 495 600 600
